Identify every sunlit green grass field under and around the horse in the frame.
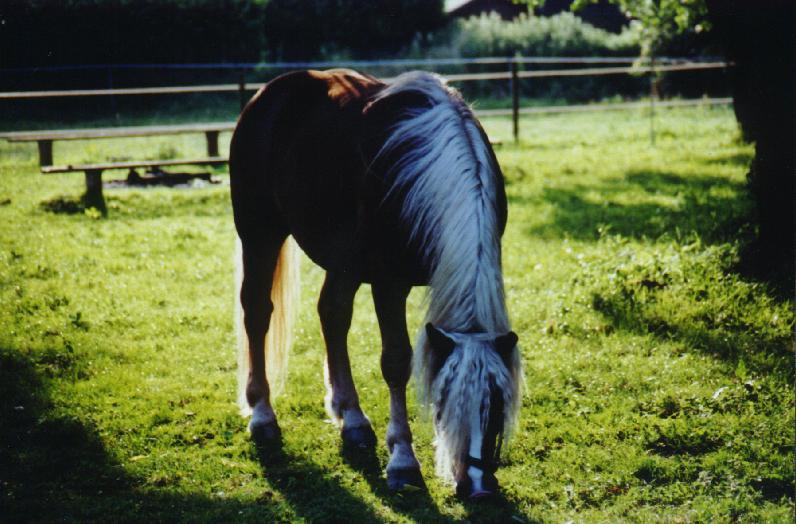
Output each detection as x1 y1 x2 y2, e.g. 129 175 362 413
0 104 794 523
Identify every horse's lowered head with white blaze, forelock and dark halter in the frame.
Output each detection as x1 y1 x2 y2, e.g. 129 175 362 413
426 324 520 498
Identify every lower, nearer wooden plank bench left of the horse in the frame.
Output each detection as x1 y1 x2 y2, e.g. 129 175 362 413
41 156 228 214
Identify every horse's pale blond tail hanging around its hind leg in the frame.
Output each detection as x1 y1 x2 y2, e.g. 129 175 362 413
235 237 301 414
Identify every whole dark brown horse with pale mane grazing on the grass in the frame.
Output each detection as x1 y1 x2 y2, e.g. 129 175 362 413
229 70 521 497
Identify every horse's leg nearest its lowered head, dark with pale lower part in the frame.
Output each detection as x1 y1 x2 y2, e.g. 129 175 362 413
372 282 424 489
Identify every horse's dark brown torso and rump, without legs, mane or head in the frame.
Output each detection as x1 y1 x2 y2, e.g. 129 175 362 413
230 70 436 284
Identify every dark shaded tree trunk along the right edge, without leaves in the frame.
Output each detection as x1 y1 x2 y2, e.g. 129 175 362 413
705 0 796 291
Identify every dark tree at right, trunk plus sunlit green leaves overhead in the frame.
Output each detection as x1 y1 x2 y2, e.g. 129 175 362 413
525 0 796 288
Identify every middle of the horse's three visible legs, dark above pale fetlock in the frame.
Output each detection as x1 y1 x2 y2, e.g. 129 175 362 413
318 272 376 447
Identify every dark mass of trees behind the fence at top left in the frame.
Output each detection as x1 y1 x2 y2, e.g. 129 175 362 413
0 0 445 67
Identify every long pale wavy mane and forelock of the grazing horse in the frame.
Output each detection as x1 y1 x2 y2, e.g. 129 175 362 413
373 72 521 482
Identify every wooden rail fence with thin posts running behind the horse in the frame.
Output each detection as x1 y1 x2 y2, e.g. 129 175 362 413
0 57 732 142
